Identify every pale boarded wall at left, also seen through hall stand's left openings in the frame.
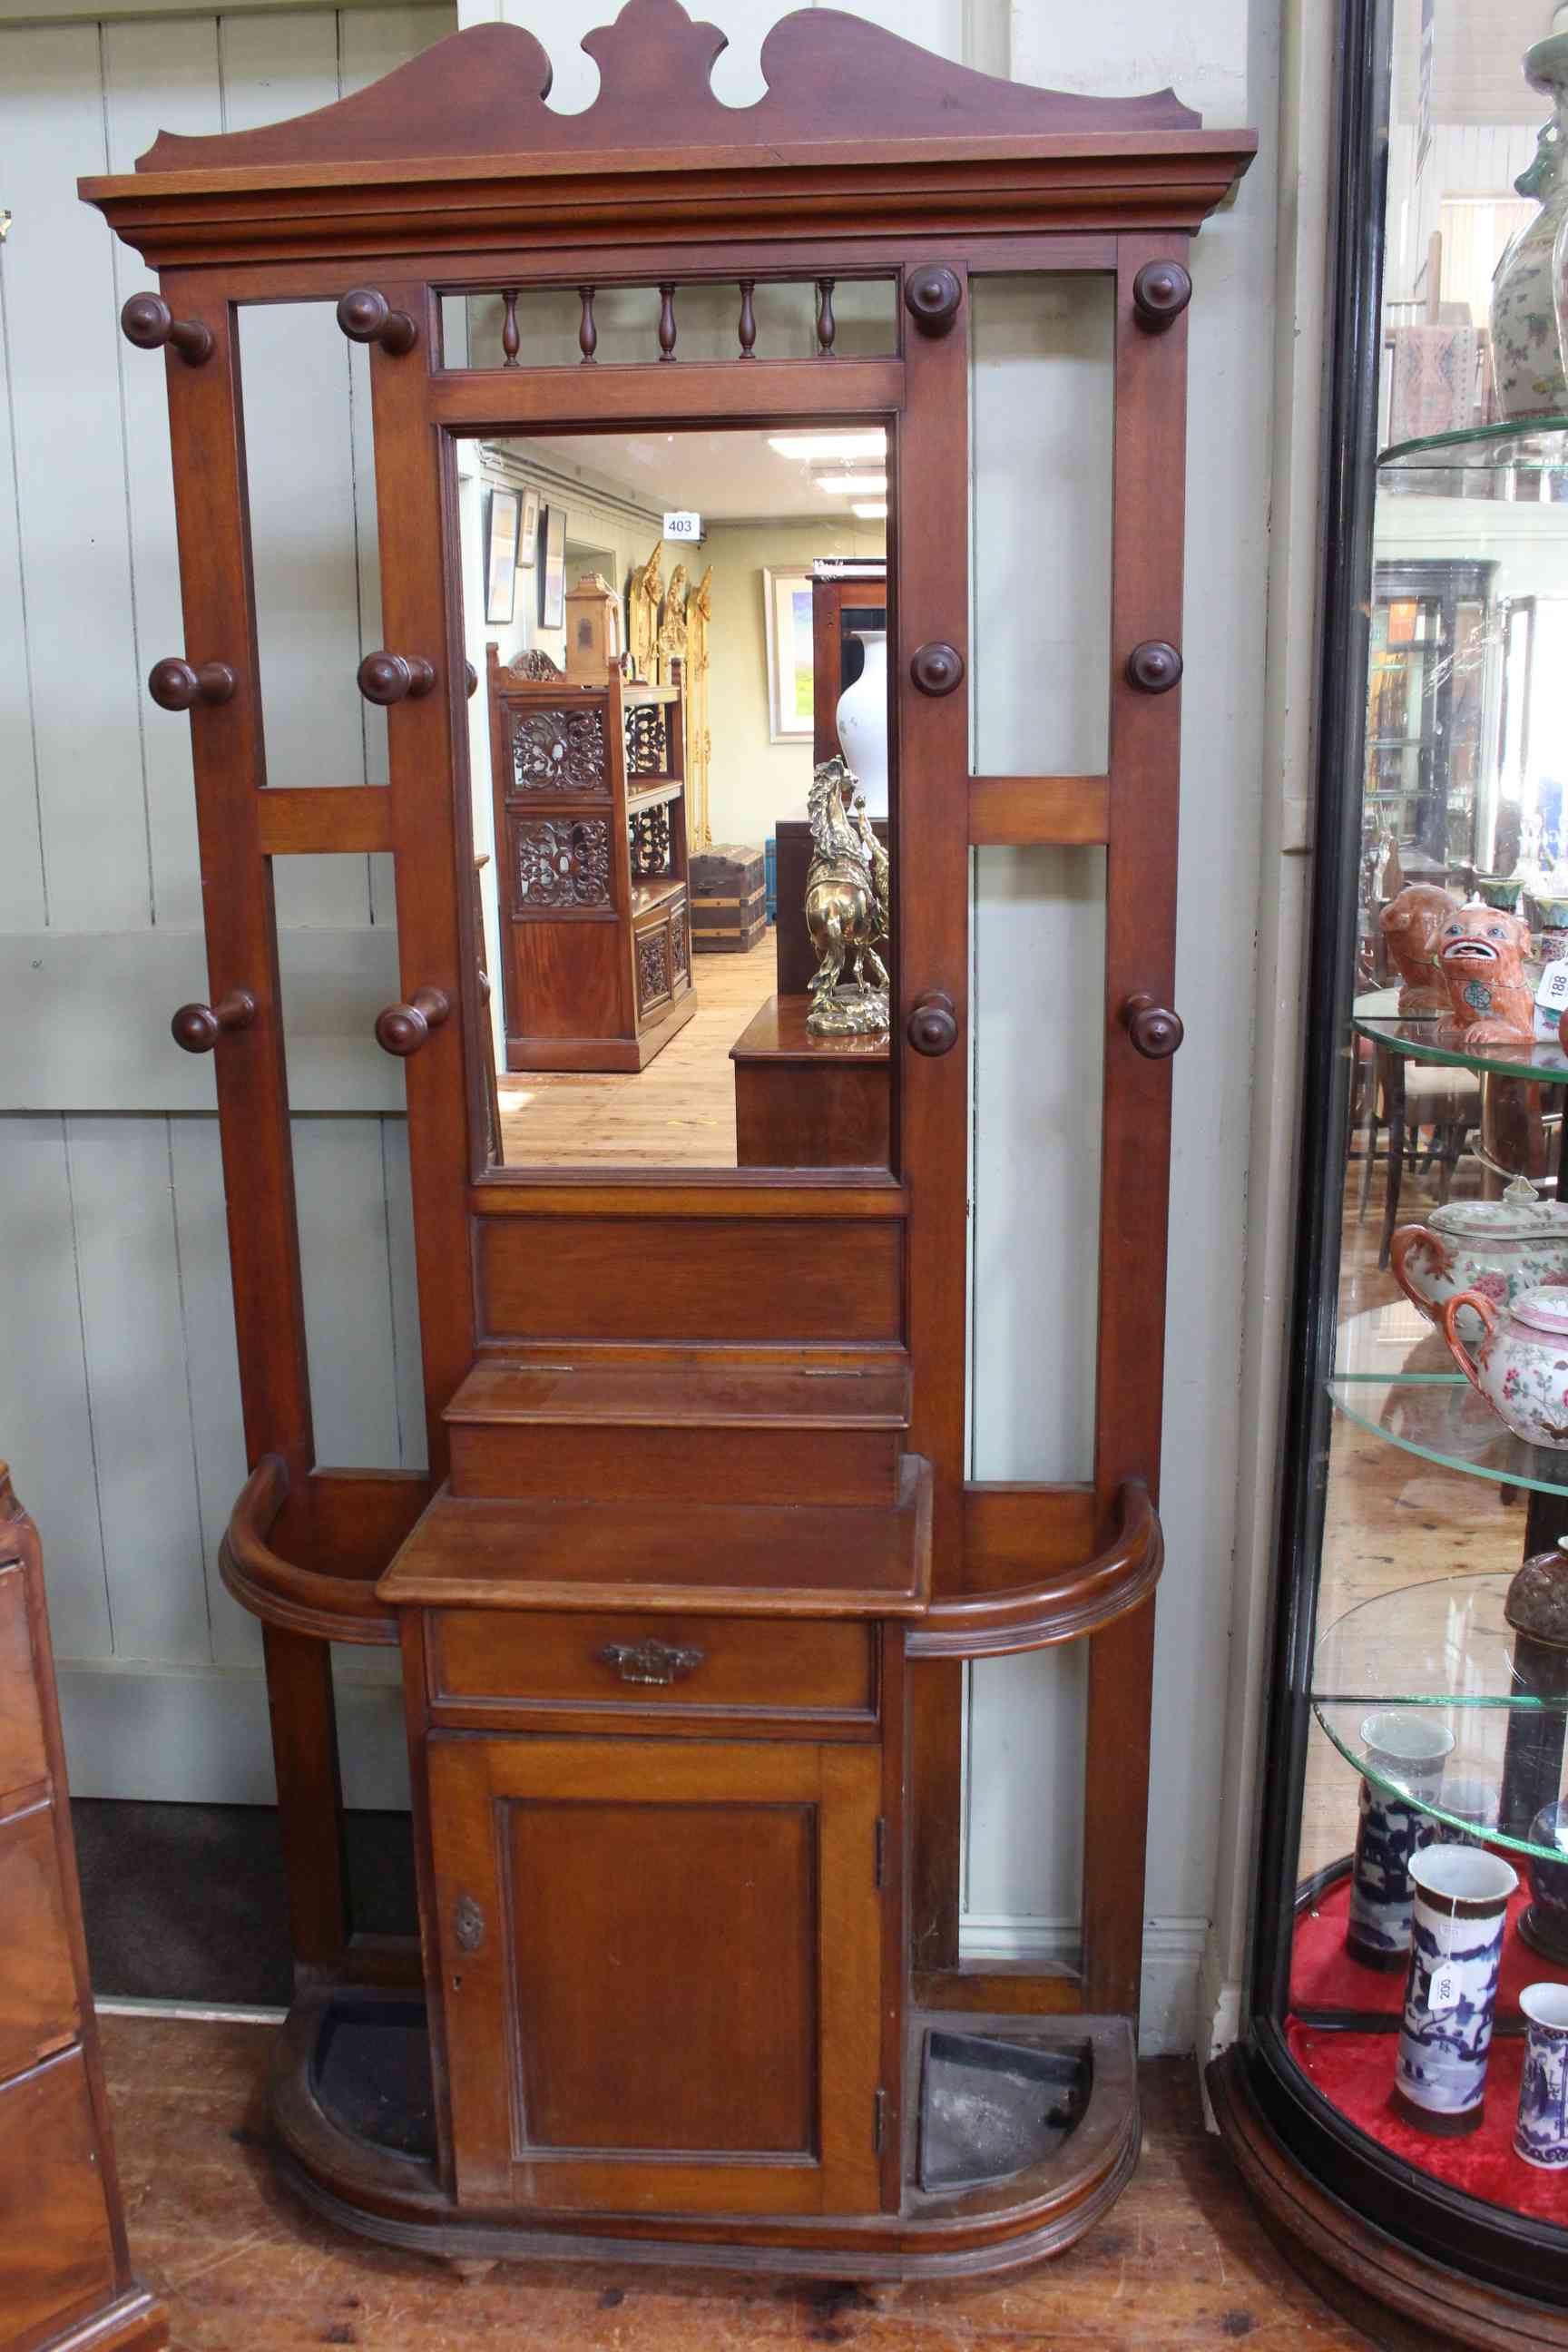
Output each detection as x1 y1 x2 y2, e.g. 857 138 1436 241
0 7 454 1801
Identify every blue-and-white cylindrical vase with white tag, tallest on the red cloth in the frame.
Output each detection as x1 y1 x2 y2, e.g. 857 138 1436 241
1394 1844 1519 2133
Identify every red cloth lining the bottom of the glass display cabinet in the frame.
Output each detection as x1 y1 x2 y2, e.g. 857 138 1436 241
1286 2023 1568 2228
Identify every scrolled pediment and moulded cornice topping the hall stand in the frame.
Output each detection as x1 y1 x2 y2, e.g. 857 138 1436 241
80 0 1255 268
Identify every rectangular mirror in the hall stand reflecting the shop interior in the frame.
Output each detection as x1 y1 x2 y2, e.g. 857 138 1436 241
454 424 896 1176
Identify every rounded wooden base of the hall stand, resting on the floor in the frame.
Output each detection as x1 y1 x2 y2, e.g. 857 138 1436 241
270 1987 1140 2281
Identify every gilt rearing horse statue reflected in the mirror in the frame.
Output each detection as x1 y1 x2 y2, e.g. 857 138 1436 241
807 755 891 1037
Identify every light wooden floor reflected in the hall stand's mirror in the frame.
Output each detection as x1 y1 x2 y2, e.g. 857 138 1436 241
498 929 779 1169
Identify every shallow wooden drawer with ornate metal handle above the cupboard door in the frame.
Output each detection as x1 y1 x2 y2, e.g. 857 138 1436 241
426 1609 877 1724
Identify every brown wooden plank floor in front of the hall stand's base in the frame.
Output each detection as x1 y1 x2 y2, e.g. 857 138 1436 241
103 2015 1366 2352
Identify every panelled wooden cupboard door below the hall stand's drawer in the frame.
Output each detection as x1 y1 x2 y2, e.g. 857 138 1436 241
430 1736 882 2213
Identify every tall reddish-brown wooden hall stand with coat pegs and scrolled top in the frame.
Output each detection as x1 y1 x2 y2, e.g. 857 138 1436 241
84 0 1253 2277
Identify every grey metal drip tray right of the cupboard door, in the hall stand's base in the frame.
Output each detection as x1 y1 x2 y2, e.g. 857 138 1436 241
919 2030 1093 2192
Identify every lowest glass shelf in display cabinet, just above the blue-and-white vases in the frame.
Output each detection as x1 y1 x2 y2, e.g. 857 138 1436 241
1312 1576 1568 1870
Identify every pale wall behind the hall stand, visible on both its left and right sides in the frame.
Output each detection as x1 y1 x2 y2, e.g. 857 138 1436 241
0 0 1284 2049
